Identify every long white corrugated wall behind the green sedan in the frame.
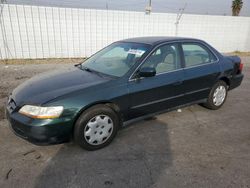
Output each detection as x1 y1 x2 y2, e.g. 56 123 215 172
0 4 250 59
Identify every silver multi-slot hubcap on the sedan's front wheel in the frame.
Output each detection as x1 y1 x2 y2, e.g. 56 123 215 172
84 115 113 145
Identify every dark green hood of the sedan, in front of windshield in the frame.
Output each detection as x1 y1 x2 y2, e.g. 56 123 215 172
11 67 111 106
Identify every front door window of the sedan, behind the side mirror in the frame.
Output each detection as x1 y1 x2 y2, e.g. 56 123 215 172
142 44 180 74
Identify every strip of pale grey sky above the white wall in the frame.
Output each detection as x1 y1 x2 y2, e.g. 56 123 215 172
7 0 250 17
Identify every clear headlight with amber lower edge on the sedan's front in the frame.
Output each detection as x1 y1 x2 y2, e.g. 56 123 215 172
19 105 63 119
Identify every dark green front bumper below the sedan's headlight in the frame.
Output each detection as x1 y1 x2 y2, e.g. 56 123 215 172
6 109 73 145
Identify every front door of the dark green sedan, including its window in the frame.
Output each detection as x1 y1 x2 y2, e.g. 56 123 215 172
128 44 185 118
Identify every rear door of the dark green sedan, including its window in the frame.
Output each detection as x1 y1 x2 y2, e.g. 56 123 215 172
182 42 220 102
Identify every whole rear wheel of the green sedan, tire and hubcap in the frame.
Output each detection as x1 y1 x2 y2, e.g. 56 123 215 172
203 80 228 110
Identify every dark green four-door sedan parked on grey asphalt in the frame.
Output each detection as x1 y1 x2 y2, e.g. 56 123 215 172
6 37 243 150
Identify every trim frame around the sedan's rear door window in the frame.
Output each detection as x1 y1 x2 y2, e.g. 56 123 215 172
180 41 219 69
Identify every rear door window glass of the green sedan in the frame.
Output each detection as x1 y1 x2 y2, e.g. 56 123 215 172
182 43 216 67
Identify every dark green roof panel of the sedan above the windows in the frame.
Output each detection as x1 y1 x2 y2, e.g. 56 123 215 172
120 36 200 45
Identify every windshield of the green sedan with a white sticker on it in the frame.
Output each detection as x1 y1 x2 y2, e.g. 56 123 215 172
82 42 150 77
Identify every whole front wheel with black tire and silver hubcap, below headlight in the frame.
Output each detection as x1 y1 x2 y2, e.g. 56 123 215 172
73 105 120 151
